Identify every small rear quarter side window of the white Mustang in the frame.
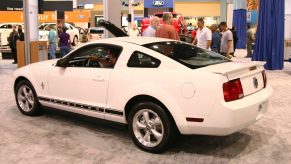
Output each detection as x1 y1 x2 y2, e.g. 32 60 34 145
127 51 161 68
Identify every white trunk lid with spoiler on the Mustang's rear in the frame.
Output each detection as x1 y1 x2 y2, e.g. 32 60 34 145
205 61 266 96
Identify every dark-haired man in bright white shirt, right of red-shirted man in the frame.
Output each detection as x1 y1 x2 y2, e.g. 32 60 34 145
193 18 212 49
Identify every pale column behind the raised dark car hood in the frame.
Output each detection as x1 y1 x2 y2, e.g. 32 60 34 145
103 0 121 38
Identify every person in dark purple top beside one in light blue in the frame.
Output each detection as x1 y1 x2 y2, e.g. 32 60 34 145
59 27 71 57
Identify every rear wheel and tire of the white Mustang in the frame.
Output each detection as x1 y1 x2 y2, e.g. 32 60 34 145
128 102 176 153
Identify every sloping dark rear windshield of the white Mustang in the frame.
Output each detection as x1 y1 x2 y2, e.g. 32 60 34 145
143 41 230 69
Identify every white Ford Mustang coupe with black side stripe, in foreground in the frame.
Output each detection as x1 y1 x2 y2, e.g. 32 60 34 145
14 22 272 153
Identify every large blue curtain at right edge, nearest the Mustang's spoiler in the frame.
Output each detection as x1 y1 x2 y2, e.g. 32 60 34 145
252 0 285 70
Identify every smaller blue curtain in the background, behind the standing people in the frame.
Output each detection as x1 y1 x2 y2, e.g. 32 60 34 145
232 9 247 49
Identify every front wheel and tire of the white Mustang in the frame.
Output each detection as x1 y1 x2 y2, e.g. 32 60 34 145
15 80 41 116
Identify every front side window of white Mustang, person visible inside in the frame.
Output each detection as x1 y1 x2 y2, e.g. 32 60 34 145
68 45 122 68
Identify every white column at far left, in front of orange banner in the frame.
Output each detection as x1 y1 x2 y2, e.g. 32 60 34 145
23 0 38 65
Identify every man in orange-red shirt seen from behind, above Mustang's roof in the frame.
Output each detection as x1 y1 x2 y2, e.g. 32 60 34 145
156 13 180 40
